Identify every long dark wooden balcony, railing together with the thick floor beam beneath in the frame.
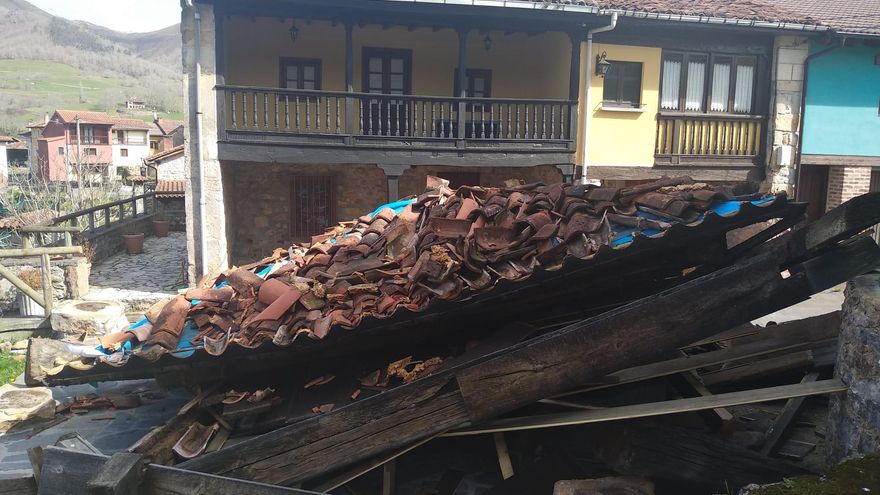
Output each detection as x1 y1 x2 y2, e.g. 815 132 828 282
216 86 577 166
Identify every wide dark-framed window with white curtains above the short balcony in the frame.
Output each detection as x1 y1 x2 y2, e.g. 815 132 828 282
660 52 757 114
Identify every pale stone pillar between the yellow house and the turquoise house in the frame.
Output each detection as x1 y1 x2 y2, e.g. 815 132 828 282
762 36 809 194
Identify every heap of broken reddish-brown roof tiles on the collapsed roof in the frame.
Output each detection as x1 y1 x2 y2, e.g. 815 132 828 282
147 177 728 354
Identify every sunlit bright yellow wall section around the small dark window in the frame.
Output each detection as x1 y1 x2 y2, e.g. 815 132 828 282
576 42 661 167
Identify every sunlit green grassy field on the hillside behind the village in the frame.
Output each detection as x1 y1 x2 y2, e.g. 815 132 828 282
0 60 182 134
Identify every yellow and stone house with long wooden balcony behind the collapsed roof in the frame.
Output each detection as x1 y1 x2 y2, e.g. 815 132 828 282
181 0 872 280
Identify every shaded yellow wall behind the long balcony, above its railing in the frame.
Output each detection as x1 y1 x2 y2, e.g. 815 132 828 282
224 17 571 99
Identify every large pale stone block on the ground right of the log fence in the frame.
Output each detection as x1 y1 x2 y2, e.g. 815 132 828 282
49 299 128 339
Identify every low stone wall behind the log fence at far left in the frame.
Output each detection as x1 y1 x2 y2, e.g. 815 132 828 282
0 256 91 317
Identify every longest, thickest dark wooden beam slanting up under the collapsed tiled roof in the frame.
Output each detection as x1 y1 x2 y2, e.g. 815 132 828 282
182 237 880 483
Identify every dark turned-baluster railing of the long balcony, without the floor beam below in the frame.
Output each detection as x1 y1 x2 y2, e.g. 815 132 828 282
217 86 577 148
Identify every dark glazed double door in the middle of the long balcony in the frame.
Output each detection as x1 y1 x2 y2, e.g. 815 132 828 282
363 47 412 136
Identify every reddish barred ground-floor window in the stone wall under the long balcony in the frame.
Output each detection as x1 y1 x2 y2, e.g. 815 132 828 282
290 175 336 240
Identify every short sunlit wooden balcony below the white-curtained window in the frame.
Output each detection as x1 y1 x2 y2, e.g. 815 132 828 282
655 114 764 166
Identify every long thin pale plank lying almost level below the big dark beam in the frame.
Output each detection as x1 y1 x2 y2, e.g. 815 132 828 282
442 378 847 437
